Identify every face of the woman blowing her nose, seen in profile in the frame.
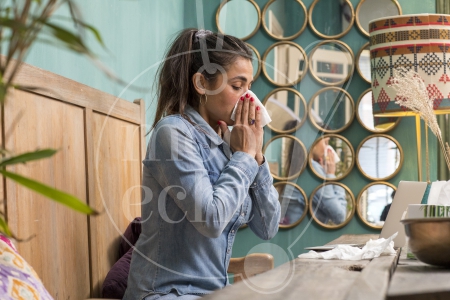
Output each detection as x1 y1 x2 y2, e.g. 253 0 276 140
199 57 253 128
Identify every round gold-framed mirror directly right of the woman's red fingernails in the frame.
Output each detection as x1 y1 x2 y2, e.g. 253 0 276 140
263 88 307 133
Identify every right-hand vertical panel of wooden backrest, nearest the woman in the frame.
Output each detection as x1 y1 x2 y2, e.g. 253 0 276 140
90 113 142 297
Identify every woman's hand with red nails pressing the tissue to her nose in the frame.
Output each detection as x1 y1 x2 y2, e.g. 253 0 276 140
219 95 264 165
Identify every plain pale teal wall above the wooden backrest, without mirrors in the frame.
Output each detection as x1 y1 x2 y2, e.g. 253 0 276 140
26 0 184 129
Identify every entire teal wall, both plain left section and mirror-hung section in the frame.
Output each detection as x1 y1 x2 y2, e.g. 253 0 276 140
23 0 436 265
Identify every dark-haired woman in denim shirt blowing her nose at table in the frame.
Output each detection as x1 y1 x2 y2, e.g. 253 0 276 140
124 29 280 300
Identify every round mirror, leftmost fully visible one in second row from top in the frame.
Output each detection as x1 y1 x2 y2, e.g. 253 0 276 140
263 42 308 87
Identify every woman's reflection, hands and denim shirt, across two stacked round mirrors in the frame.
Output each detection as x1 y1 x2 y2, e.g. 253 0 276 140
311 137 347 225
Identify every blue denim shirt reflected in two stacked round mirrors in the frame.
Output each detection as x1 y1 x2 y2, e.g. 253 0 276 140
311 160 347 225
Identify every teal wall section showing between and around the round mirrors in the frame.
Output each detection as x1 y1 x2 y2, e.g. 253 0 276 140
185 0 437 265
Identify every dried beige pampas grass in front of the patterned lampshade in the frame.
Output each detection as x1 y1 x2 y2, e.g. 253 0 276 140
390 68 450 170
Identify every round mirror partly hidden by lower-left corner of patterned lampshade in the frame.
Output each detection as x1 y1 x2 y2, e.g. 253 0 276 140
356 88 400 133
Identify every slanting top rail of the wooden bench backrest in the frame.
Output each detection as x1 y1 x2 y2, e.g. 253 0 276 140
6 59 141 124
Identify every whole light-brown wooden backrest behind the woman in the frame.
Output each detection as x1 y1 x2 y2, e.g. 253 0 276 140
0 65 145 299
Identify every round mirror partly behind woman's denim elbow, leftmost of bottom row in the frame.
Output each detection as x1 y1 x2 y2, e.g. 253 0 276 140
273 182 308 228
